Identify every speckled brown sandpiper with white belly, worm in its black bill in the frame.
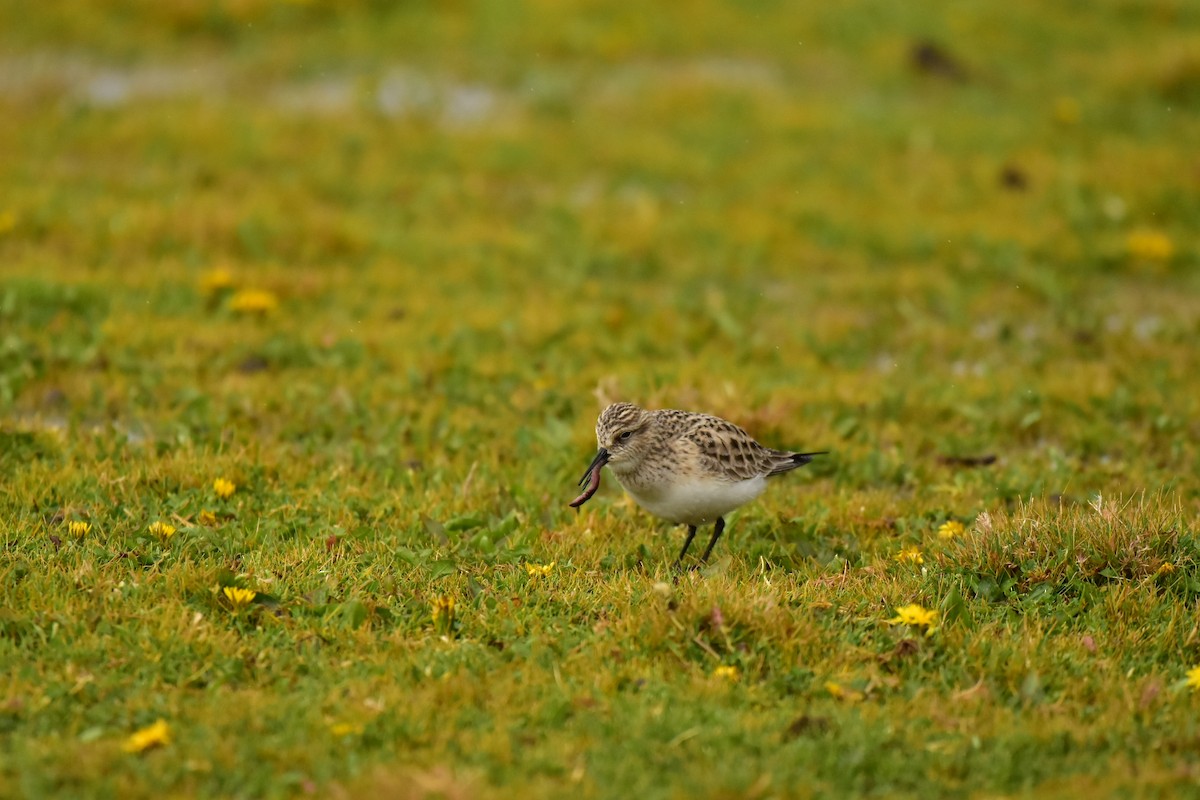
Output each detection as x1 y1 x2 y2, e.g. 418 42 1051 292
571 403 827 566
